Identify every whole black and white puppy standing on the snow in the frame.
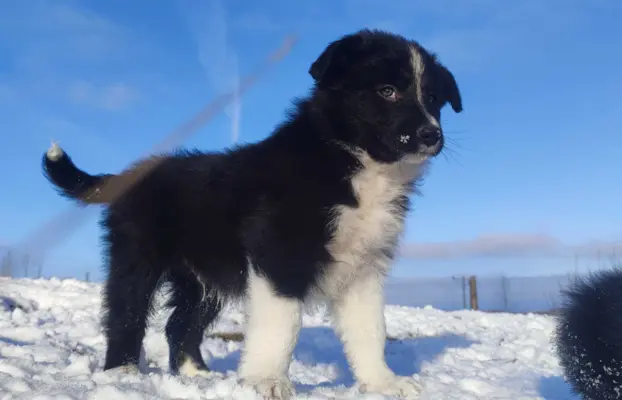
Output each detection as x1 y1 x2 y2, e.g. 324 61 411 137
43 30 462 399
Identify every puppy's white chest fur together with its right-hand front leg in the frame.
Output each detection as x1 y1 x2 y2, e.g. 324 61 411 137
320 151 427 398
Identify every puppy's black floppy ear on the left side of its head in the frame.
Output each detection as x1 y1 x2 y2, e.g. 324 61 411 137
309 35 364 87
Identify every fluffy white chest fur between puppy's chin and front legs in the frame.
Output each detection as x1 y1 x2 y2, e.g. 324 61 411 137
321 153 425 297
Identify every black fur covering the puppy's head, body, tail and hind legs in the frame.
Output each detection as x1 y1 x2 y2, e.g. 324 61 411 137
44 30 462 376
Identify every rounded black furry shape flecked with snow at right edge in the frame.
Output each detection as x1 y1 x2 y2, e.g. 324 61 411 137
554 269 622 400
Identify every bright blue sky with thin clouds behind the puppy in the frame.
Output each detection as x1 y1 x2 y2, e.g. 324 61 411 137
0 0 622 278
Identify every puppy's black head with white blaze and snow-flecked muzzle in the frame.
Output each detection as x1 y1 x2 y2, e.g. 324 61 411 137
309 30 462 162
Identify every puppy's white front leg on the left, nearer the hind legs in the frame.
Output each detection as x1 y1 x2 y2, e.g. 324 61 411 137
239 273 302 400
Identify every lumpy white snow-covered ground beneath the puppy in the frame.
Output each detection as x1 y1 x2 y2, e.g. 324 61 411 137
0 278 579 400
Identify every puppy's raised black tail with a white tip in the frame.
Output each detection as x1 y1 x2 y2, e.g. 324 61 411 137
42 143 114 205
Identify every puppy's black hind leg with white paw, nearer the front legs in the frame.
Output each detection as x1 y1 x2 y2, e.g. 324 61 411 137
166 272 222 377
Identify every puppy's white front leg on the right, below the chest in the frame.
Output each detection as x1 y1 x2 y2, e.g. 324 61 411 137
333 273 421 399
